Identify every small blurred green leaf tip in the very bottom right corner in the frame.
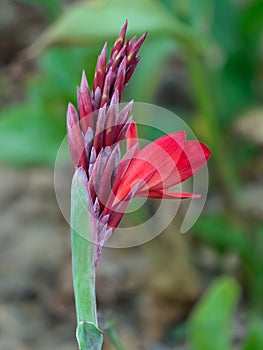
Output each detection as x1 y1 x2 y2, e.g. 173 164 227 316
242 319 263 350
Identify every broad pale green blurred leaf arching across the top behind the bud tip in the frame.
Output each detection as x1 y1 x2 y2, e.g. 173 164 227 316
28 0 204 56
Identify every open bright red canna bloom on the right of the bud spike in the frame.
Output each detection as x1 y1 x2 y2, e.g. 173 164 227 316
104 122 210 227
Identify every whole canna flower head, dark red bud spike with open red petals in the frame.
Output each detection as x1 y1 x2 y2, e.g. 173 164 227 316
67 21 210 263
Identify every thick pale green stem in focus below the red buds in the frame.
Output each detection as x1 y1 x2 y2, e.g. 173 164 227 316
71 169 102 350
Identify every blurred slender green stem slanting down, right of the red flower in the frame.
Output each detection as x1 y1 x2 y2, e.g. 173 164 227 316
187 50 239 222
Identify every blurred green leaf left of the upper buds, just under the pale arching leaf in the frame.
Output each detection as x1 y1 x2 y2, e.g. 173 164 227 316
27 44 102 103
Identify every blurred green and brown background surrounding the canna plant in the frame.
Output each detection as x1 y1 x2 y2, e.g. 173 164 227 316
0 0 263 350
